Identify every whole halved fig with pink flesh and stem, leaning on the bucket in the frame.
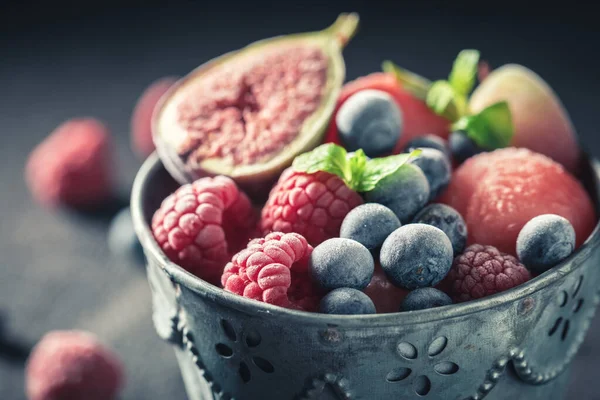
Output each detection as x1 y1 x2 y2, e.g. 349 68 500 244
152 13 358 198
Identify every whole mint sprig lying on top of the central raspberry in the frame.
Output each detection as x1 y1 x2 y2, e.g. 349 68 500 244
292 143 421 193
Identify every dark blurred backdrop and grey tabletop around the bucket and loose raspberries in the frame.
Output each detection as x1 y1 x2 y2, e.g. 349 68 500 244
0 0 600 400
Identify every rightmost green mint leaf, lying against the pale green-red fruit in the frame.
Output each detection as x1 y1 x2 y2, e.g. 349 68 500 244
452 101 514 150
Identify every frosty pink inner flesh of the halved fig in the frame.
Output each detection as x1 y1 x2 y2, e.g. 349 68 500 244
177 45 328 165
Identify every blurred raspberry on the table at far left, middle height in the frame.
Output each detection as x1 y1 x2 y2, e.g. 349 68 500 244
25 118 113 207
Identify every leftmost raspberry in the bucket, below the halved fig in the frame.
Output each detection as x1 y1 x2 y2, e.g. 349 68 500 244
152 176 256 284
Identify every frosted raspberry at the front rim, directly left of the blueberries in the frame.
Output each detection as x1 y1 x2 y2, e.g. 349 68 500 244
221 232 320 311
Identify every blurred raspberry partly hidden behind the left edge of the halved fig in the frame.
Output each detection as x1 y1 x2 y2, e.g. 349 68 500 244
130 76 177 157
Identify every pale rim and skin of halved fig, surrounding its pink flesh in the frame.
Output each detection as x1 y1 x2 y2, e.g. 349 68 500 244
152 13 359 203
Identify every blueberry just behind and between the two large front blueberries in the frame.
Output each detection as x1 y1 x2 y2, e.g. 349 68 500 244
340 203 401 250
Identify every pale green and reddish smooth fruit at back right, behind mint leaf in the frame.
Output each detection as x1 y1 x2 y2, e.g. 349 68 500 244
469 64 580 172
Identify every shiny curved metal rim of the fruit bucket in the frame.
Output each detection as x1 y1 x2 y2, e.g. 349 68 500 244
131 152 600 327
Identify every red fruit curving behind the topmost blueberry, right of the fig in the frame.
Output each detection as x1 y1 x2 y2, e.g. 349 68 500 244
325 72 450 154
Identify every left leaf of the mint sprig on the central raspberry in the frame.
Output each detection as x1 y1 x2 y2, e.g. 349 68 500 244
292 143 352 182
